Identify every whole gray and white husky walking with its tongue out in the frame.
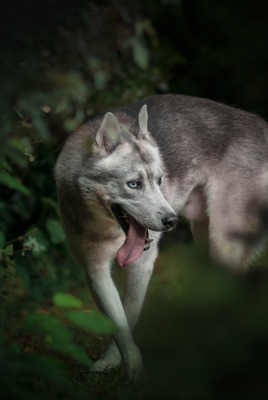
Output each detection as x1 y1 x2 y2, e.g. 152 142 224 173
56 95 268 381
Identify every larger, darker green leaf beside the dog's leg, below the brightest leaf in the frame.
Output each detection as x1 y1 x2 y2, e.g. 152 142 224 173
65 311 116 335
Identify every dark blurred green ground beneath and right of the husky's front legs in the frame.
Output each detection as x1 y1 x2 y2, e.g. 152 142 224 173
68 228 268 400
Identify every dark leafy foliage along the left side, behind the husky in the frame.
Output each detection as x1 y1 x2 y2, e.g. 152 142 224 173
0 0 163 399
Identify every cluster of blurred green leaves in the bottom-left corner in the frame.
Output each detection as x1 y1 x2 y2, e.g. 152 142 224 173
0 293 114 399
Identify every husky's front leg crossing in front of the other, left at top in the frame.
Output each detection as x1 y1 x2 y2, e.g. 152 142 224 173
70 235 144 382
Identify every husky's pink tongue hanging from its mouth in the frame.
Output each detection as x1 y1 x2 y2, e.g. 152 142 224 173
116 218 147 267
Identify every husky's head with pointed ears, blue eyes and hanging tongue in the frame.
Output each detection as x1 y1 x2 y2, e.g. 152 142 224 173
80 105 177 265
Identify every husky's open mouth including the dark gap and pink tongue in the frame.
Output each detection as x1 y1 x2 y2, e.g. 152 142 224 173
111 204 152 266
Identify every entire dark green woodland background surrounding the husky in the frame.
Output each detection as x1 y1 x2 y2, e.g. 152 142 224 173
0 0 268 400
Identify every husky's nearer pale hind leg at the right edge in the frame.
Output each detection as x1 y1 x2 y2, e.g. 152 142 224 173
208 179 265 271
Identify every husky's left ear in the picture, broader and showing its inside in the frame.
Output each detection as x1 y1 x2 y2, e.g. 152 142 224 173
94 112 121 153
